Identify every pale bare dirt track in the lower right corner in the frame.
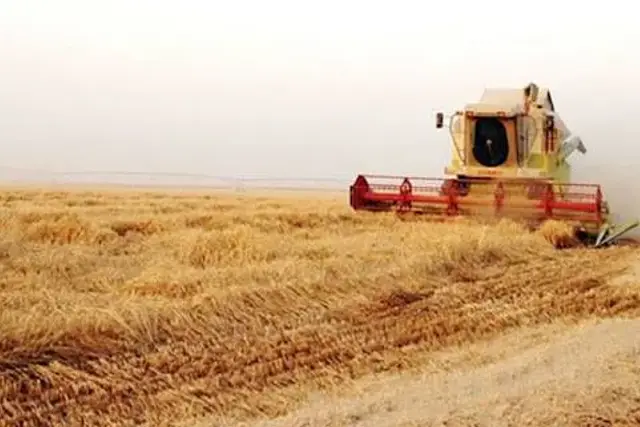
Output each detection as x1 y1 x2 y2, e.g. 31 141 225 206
249 319 640 427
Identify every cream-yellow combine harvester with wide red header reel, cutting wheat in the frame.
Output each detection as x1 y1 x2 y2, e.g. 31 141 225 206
350 83 640 247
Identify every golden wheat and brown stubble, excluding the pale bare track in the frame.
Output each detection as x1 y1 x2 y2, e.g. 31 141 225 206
0 189 640 425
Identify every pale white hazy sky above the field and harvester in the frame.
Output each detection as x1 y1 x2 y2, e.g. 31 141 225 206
0 0 640 184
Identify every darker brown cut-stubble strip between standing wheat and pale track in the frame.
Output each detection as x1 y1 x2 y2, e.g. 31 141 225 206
0 250 640 425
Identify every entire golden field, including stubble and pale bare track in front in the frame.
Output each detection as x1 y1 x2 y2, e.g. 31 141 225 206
0 188 640 427
